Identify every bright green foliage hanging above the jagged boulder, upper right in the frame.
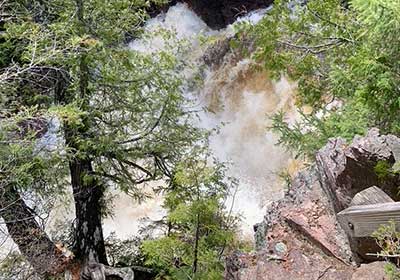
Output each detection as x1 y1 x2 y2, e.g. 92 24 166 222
251 0 400 156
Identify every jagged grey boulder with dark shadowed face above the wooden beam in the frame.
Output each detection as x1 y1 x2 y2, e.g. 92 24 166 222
316 129 400 212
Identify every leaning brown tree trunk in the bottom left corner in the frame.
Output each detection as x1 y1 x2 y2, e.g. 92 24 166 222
0 187 70 277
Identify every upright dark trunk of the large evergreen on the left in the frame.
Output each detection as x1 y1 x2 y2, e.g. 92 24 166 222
65 0 107 266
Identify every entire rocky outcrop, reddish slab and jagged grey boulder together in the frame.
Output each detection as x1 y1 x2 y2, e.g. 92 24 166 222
225 129 400 280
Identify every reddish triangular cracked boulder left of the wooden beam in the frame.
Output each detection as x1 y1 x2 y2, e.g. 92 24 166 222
225 168 354 280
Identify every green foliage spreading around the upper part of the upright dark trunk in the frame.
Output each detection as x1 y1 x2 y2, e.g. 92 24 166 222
0 0 206 199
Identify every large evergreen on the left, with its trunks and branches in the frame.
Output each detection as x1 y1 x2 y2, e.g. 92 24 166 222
0 0 208 279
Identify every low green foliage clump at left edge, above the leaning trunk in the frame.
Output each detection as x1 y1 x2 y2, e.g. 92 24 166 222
0 108 66 196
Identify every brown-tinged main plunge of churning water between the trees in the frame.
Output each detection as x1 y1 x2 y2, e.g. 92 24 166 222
198 50 299 235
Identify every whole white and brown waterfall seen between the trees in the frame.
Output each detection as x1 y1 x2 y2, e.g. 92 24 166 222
105 4 297 237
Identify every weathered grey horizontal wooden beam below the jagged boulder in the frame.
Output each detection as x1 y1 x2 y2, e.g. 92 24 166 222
338 202 400 237
